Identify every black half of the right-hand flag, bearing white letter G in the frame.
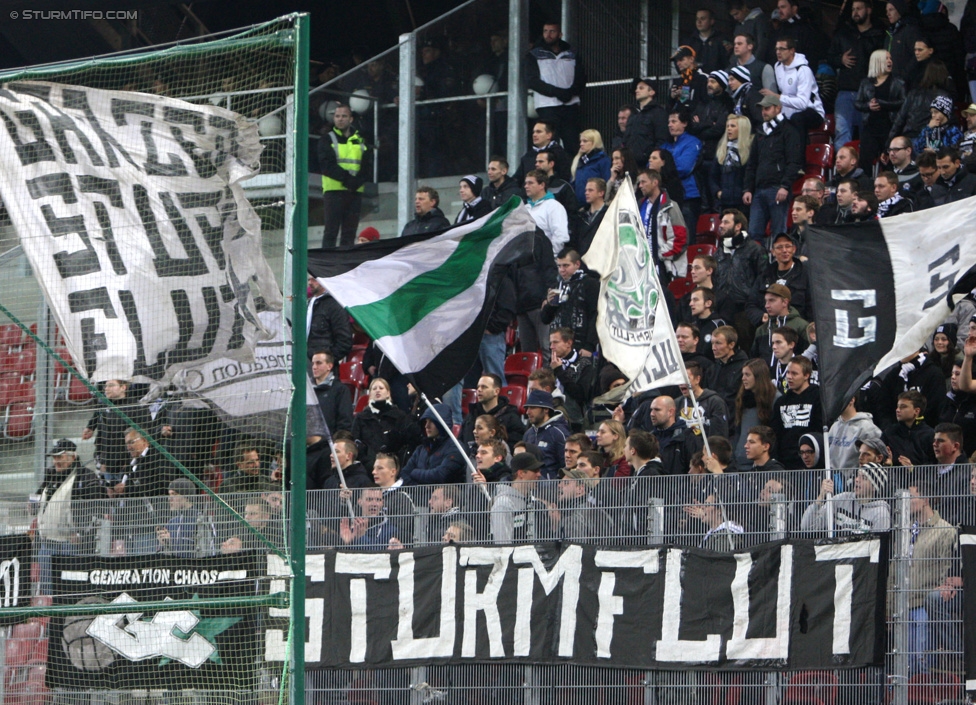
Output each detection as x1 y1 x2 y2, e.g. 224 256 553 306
807 220 896 423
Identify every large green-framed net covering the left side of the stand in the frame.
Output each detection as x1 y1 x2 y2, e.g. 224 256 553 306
0 17 308 703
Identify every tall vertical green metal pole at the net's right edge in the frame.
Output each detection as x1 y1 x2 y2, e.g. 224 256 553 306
289 14 310 705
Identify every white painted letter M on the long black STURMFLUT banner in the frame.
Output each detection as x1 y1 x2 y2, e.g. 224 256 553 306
513 546 583 657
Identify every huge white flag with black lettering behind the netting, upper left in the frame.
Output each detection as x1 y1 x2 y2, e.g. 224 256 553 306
0 82 281 381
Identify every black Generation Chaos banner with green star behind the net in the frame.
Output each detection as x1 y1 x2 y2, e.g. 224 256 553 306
47 554 265 690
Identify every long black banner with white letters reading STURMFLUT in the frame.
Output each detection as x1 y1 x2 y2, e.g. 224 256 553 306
305 536 888 670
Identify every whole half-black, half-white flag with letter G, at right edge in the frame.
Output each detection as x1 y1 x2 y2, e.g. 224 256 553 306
807 198 976 419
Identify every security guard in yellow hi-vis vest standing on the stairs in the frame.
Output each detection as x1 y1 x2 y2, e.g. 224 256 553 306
319 105 367 247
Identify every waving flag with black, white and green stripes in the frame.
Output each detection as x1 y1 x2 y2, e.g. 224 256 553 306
308 196 536 397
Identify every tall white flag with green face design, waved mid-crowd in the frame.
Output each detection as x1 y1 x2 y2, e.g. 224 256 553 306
583 177 688 401
